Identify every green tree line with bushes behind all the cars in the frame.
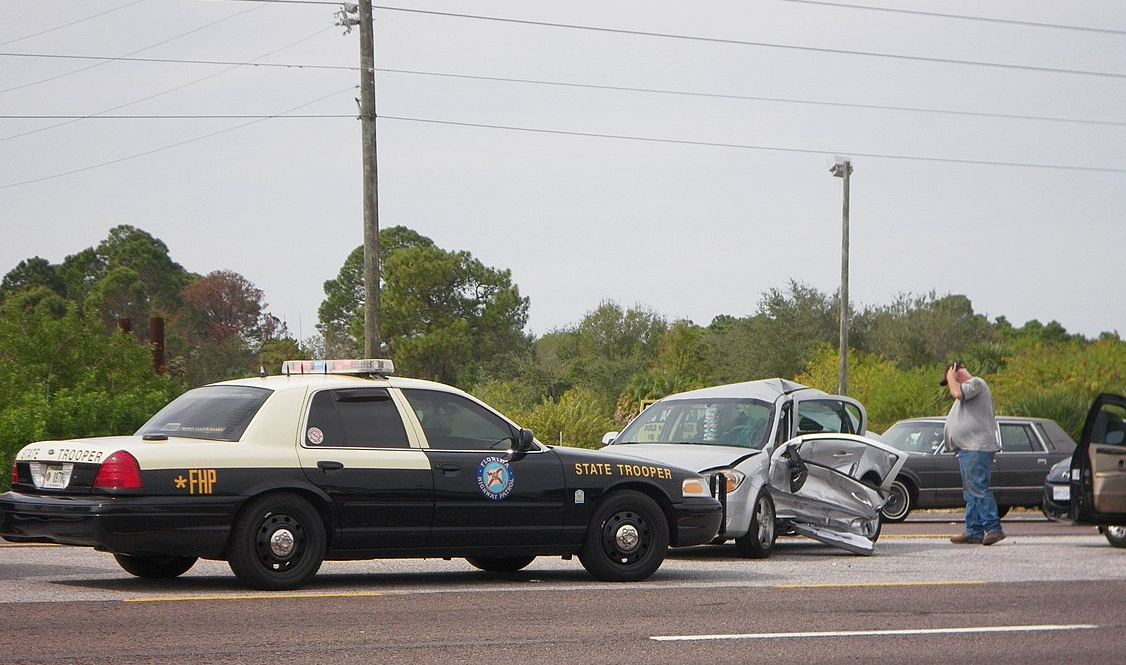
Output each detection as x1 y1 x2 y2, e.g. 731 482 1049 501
0 226 1126 484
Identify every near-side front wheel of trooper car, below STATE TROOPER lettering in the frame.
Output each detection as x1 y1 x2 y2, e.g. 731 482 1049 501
579 489 669 582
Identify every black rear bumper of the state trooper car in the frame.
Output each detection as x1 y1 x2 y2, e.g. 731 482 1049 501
0 492 239 558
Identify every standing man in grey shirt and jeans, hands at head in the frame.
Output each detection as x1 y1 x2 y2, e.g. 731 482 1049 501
942 362 1004 545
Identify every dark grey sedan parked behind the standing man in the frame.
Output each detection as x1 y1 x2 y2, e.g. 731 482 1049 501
881 416 1075 522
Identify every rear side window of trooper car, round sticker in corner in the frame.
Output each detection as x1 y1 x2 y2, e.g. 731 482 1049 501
305 388 410 448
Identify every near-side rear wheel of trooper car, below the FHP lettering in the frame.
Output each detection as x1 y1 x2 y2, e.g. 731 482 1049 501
227 494 325 591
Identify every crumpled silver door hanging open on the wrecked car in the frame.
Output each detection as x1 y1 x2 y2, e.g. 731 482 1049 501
770 434 908 555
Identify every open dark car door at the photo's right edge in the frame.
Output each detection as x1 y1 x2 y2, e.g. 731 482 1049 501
1071 394 1126 525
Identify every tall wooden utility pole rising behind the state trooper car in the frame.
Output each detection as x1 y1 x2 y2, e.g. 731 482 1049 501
337 0 383 358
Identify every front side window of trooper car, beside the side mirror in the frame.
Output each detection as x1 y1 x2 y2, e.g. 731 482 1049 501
403 388 512 450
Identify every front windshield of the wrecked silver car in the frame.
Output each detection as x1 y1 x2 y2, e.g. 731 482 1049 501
615 398 774 449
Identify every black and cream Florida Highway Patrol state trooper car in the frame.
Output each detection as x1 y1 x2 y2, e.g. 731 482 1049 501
0 360 722 590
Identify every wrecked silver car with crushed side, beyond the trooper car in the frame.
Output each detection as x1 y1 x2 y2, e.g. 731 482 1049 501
602 379 906 558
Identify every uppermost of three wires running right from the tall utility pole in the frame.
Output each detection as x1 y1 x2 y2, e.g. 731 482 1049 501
375 7 1126 79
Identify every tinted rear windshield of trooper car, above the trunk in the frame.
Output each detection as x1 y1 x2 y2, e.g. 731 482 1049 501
136 386 272 441
